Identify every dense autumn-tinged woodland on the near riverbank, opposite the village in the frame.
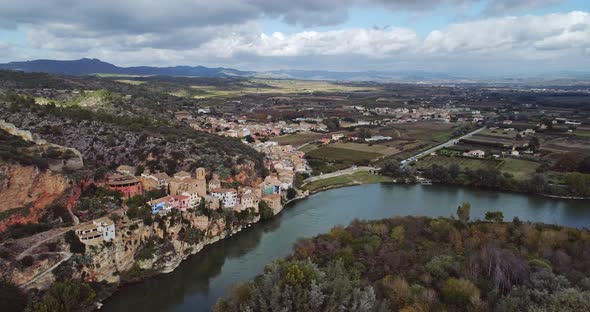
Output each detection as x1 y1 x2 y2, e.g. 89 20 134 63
216 217 590 311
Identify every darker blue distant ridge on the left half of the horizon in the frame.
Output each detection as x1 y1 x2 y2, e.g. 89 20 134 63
0 58 254 77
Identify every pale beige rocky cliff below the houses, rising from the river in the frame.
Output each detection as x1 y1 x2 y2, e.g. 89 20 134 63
21 212 259 289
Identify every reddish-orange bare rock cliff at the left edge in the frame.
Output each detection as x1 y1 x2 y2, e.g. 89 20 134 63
0 163 70 231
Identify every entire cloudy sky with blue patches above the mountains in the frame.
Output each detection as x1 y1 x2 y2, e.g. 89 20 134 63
0 0 590 75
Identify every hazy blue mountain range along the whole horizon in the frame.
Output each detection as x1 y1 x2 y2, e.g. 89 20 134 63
0 58 590 82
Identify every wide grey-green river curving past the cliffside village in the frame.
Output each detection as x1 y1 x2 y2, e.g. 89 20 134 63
101 184 590 311
